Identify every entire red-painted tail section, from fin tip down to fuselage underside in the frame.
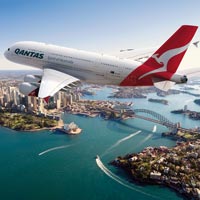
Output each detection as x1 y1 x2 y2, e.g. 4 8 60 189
121 25 198 86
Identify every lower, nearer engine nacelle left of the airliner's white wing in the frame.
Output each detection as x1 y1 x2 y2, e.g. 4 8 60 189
19 82 40 97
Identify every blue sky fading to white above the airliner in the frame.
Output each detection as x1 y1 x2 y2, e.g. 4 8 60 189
0 0 200 69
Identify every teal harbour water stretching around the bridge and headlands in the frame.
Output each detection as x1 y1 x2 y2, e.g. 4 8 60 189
0 85 200 200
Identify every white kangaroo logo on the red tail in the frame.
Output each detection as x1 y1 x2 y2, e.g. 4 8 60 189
138 43 189 80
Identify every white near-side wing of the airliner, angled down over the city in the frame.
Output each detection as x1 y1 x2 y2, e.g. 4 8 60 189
38 68 79 102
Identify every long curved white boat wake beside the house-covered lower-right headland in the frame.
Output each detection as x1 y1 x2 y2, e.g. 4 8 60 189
96 156 159 199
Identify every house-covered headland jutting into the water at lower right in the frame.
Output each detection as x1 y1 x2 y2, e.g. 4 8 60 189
111 139 200 199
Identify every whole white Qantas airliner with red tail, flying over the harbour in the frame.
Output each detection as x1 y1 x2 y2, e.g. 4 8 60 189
4 25 198 102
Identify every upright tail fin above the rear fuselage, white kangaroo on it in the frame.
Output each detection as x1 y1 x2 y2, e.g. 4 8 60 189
138 25 198 79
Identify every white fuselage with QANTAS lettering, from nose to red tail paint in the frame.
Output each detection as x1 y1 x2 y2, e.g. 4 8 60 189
5 42 141 85
